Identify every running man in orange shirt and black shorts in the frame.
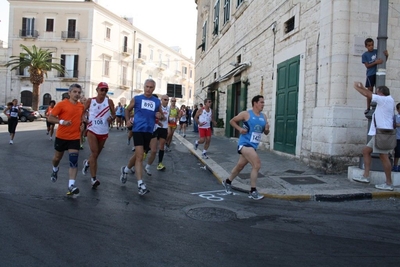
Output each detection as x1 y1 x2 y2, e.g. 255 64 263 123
49 83 84 195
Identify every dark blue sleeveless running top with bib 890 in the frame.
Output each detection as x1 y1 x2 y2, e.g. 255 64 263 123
132 95 161 133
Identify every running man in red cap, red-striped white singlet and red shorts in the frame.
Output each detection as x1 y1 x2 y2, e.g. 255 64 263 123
82 82 115 189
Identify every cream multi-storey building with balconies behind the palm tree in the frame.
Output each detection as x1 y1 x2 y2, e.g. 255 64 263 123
4 0 194 108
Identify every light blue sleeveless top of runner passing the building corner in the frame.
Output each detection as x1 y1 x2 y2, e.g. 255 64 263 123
238 110 267 149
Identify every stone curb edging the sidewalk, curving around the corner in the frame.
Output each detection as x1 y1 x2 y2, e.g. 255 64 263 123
174 133 400 202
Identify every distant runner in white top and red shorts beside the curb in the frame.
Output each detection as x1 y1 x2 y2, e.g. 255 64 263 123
194 98 217 159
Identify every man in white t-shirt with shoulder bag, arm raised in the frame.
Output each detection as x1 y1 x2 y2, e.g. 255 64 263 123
353 82 394 191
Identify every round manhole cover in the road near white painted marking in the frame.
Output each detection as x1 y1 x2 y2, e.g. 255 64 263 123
186 207 237 222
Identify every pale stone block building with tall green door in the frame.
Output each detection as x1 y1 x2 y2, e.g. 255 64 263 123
195 0 400 173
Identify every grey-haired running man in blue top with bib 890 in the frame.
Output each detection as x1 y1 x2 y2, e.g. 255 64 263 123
120 79 164 195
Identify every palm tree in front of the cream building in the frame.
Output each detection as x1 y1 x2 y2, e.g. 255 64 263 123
6 44 65 110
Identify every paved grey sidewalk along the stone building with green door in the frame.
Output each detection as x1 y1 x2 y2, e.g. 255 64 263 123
172 126 400 201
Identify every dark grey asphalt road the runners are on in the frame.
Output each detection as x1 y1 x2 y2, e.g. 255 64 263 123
0 121 400 267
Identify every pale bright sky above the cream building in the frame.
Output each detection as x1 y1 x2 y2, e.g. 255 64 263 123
0 0 197 60
